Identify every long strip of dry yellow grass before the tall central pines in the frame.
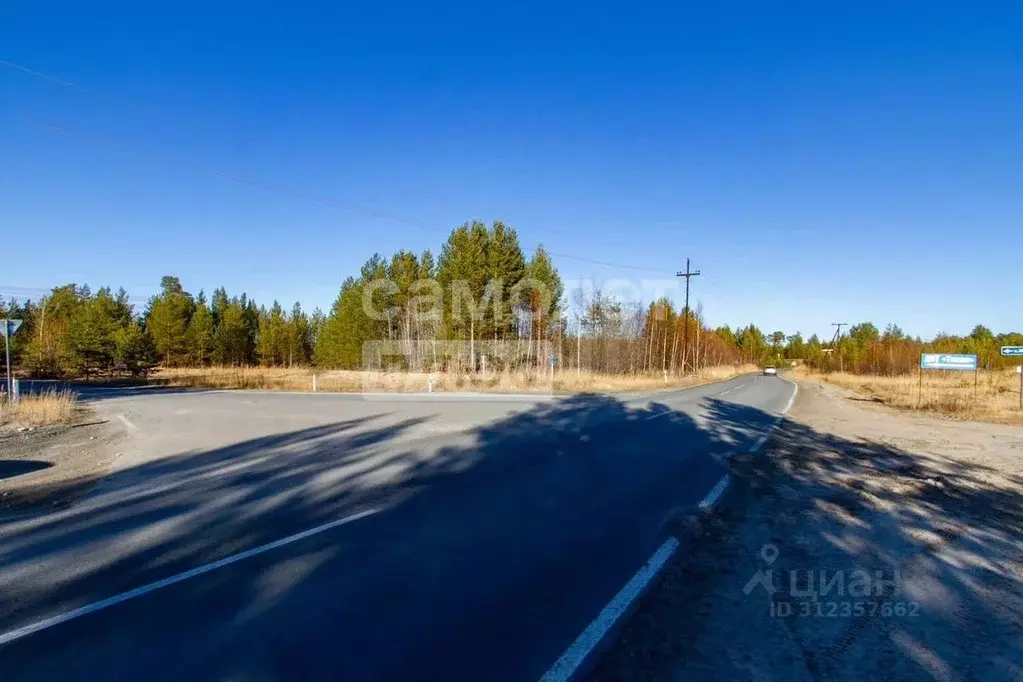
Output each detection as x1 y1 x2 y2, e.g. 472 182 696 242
149 365 756 393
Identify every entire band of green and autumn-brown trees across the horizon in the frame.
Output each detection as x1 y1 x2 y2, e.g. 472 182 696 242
6 221 1023 377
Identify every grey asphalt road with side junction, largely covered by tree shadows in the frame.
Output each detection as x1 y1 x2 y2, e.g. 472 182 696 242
0 376 793 682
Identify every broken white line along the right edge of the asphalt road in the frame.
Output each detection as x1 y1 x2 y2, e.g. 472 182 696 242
540 377 799 682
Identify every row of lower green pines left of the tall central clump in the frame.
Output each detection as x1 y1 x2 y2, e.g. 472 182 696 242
0 276 322 378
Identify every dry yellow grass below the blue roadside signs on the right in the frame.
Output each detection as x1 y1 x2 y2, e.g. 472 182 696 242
797 369 1023 424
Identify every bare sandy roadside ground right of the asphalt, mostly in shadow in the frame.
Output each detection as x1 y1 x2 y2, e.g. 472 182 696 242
593 382 1023 680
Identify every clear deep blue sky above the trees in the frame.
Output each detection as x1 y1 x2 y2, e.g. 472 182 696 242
0 0 1023 336
